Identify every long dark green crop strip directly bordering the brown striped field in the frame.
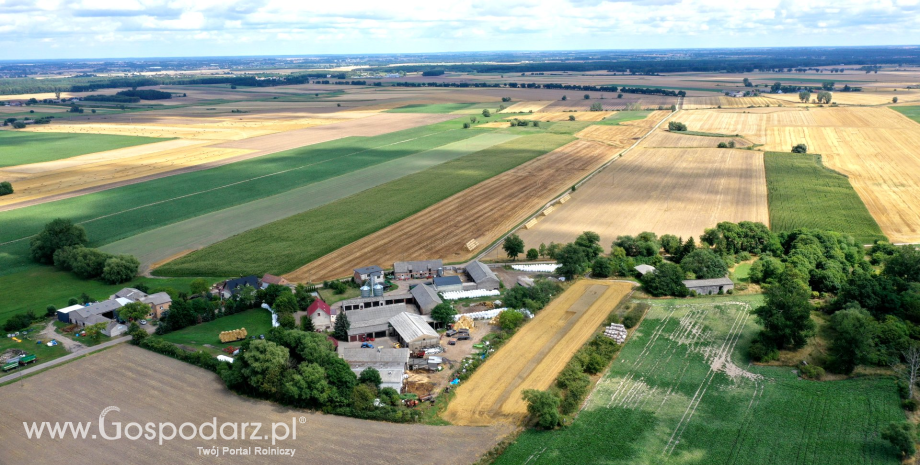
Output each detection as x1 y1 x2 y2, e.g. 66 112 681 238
155 130 572 276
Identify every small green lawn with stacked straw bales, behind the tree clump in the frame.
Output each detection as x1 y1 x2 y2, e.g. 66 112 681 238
154 308 272 355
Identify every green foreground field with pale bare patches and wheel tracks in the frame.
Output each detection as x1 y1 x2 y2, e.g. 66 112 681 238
495 296 904 465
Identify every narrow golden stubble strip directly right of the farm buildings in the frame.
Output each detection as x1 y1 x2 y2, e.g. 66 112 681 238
442 279 634 426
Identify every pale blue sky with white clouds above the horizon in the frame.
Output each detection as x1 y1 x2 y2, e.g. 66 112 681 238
0 0 920 60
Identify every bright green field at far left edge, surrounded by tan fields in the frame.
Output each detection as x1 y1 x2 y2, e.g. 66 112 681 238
0 130 169 167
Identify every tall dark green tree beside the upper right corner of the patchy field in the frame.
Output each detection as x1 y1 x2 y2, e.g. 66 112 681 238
754 265 815 349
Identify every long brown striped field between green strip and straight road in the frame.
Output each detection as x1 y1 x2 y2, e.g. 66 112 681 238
285 136 619 282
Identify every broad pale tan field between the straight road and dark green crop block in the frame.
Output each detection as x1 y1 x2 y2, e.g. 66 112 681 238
510 148 770 254
